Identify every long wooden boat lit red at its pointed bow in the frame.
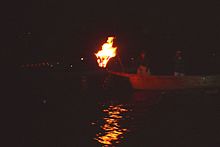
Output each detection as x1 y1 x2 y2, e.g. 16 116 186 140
109 71 220 90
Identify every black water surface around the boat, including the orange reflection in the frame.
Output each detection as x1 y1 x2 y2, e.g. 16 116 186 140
2 72 220 147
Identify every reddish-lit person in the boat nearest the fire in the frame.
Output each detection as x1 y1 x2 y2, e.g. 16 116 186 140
137 50 150 75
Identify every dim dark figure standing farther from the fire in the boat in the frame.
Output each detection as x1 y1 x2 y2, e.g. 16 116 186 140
174 50 185 76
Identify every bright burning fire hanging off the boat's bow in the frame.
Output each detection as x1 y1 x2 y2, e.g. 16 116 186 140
95 37 117 68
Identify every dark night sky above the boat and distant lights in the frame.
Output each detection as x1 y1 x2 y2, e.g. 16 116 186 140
3 0 220 72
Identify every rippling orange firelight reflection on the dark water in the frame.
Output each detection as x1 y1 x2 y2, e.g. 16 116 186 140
95 105 128 146
